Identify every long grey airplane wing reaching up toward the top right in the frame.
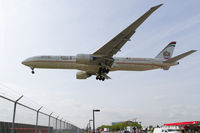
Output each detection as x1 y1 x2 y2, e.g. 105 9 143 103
93 4 163 57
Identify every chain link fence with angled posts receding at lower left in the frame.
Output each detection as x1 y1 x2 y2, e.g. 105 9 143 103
0 95 82 133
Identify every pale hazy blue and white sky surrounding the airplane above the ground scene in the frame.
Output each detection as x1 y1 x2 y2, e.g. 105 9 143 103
0 0 200 127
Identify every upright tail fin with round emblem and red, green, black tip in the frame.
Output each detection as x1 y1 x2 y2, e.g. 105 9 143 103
155 42 176 60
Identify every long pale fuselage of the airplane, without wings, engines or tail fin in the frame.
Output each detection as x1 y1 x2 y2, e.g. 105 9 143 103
22 56 177 74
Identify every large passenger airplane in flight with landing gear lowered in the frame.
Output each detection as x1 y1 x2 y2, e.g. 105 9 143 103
22 4 196 81
